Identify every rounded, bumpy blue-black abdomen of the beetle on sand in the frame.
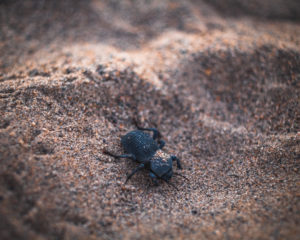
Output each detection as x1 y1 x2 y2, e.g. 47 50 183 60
121 130 158 162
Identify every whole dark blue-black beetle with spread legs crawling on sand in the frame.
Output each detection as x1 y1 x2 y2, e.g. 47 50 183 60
103 127 185 190
